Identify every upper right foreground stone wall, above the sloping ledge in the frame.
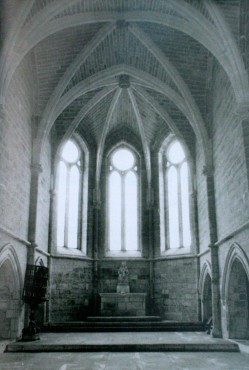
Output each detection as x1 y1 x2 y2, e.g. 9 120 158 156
213 66 249 239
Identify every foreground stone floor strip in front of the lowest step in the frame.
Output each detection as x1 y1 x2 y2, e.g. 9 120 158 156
0 352 249 370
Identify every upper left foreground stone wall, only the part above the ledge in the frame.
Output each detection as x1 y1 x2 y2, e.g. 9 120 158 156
0 63 32 239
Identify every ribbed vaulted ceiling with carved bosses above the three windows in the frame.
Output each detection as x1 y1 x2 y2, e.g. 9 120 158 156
0 0 249 182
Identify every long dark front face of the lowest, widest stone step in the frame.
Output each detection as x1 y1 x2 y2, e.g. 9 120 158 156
5 342 239 353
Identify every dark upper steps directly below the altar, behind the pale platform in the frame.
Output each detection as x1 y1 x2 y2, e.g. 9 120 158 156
43 316 204 333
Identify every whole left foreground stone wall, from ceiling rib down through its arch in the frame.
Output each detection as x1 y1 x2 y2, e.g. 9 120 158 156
0 52 33 338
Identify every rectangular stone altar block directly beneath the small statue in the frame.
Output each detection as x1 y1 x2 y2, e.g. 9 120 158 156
100 293 146 316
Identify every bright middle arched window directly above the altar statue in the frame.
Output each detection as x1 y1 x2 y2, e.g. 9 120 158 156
107 146 139 252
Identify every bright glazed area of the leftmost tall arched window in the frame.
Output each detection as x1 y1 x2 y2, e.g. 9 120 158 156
56 140 83 249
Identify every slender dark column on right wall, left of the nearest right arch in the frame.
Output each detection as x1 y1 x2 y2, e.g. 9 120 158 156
203 164 222 338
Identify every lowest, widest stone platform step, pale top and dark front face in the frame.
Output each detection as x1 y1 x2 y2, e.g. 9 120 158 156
5 332 239 352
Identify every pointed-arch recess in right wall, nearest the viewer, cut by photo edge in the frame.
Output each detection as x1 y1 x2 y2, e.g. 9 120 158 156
227 258 249 339
